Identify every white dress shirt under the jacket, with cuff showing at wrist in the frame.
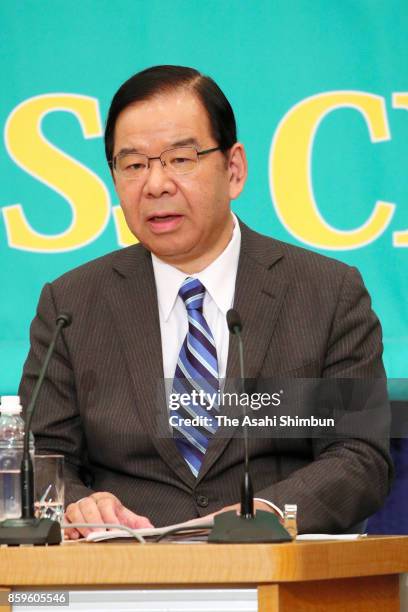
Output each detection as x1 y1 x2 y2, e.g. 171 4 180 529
152 214 283 516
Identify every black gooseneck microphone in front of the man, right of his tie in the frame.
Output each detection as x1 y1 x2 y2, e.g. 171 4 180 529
208 308 292 543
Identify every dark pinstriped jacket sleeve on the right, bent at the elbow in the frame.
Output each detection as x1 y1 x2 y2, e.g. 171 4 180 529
256 268 392 532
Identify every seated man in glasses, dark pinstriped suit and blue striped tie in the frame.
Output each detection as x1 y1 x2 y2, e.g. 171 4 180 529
20 66 391 538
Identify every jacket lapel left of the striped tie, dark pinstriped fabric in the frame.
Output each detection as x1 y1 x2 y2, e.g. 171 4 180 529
106 245 195 486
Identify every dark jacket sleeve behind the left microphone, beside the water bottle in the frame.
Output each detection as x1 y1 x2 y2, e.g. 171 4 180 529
19 284 92 505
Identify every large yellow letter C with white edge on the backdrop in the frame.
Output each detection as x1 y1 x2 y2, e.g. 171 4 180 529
270 91 395 250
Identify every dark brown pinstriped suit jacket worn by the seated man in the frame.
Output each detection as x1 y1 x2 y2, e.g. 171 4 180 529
20 219 392 532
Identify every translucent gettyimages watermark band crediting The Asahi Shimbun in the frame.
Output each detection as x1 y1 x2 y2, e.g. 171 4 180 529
154 376 392 440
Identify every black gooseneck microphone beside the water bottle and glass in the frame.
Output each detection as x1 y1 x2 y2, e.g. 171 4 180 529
0 312 72 546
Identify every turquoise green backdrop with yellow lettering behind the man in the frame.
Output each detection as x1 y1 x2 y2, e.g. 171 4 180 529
0 0 408 394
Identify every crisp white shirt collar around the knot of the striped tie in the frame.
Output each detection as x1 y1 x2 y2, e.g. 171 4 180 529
152 213 241 321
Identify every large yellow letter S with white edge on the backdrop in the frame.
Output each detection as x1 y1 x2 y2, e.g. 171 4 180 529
3 94 110 252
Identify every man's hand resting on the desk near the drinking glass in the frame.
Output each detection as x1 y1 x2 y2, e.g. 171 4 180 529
65 492 153 540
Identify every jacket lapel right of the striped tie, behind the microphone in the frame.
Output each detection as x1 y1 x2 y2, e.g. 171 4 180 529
197 223 288 482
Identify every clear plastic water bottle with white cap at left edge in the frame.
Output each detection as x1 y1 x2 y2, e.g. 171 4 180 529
0 395 34 521
